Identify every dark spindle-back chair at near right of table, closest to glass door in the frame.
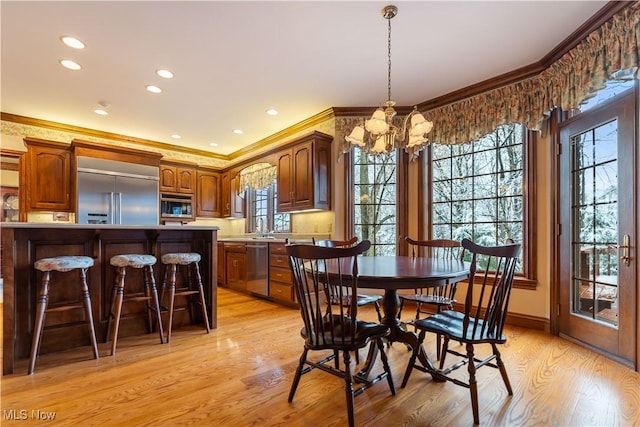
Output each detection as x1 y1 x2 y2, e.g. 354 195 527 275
402 239 520 424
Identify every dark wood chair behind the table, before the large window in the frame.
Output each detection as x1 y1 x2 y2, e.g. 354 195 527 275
398 237 464 360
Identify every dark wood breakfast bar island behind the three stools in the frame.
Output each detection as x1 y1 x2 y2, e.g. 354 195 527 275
0 223 218 375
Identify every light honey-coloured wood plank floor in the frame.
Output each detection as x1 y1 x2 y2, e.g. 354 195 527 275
0 289 640 427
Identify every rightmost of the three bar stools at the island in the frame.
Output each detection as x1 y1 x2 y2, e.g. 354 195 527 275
161 252 210 342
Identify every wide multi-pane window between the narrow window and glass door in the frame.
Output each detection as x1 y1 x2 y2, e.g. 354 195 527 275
431 125 527 273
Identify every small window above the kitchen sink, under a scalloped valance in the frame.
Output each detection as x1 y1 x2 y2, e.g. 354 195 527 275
245 183 291 233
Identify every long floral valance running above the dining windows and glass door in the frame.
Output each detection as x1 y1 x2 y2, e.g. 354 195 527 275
336 1 640 150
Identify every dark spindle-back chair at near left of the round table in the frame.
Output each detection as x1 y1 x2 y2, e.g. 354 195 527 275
286 240 396 426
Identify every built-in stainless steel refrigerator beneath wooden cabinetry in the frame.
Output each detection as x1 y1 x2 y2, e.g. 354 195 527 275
76 157 159 225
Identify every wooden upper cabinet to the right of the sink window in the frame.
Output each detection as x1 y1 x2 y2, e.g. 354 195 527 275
276 132 332 212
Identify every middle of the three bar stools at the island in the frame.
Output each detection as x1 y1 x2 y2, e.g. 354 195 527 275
105 254 164 356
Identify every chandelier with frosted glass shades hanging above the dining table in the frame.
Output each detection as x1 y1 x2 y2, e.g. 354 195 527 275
345 5 433 154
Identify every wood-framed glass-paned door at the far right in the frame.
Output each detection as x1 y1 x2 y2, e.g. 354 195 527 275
558 90 638 365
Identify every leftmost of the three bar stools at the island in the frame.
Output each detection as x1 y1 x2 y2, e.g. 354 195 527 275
28 256 100 375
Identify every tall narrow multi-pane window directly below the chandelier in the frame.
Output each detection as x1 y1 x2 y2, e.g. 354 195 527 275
351 148 397 256
